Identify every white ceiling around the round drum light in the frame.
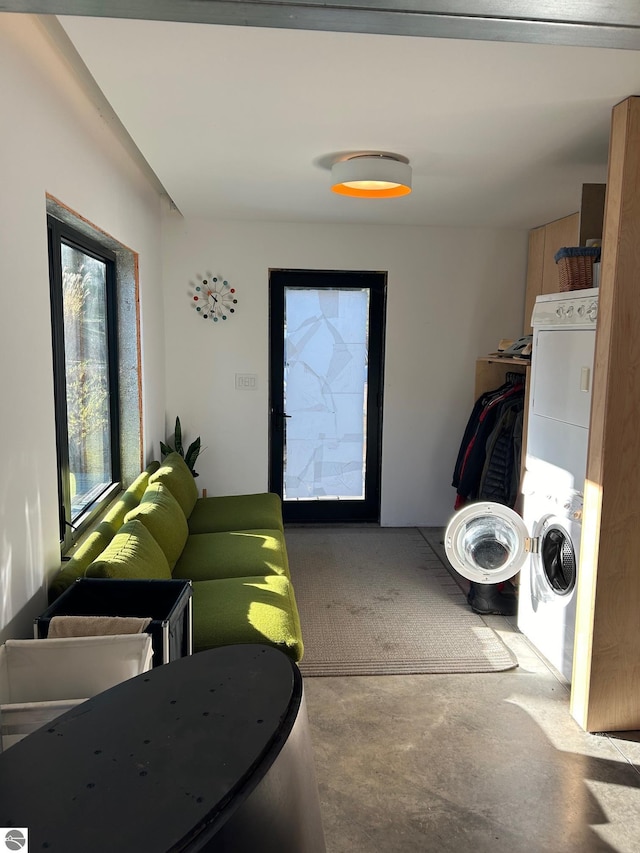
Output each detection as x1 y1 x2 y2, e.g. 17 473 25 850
53 17 640 228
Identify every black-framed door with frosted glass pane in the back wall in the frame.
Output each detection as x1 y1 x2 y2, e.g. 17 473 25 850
269 270 386 522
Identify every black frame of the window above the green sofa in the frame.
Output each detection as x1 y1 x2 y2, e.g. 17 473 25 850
47 214 122 553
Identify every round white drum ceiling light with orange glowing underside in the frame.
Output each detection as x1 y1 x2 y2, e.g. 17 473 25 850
331 154 411 198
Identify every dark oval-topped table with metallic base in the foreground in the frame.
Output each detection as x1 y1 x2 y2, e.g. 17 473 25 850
0 645 325 853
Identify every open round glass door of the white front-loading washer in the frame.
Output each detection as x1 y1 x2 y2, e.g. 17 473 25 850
444 502 529 583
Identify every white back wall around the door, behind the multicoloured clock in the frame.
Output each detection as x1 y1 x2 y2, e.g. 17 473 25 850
163 213 527 526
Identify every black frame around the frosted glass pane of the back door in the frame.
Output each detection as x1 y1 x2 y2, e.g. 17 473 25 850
269 268 387 523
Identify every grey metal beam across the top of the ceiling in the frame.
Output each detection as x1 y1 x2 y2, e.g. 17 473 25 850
0 0 640 50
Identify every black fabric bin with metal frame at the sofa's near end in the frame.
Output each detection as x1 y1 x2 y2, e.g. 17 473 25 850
34 578 193 666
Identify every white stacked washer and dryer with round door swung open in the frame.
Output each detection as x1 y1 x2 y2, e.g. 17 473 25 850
445 288 598 681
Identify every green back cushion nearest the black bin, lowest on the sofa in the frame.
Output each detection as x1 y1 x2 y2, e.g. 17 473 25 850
85 519 171 579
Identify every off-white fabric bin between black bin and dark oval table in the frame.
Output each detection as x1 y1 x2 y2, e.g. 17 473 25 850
0 634 153 752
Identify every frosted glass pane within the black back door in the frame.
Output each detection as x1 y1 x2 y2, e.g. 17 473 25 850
283 287 369 501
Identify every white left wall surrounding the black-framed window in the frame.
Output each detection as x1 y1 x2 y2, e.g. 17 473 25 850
0 14 165 641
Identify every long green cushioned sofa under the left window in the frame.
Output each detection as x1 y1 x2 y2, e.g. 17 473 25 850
49 453 303 661
